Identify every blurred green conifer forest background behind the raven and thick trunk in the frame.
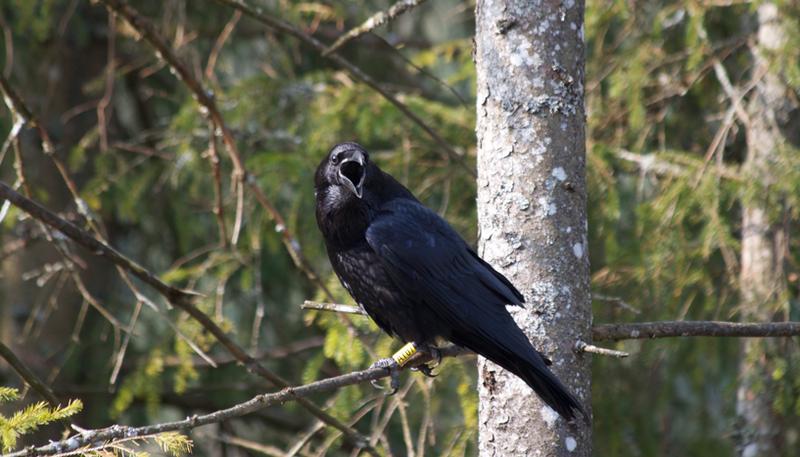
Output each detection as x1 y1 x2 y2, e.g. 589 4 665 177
0 0 800 456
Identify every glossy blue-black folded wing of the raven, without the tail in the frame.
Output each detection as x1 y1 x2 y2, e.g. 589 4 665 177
366 199 524 312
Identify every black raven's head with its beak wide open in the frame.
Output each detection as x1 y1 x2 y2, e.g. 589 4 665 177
314 143 370 198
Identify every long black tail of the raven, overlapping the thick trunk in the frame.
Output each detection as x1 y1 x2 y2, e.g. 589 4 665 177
452 328 589 421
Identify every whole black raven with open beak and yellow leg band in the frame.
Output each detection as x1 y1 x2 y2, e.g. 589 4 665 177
314 143 586 420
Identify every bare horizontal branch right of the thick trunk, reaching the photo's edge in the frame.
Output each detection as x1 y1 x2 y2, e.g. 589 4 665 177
592 321 800 341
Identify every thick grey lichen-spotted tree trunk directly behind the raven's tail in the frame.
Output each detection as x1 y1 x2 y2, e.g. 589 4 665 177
475 0 591 456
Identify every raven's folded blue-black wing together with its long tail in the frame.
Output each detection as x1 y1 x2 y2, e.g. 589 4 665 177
367 199 587 419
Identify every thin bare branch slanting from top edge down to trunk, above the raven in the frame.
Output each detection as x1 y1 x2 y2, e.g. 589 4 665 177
215 0 477 176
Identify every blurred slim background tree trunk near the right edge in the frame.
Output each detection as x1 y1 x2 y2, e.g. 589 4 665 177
736 3 792 457
